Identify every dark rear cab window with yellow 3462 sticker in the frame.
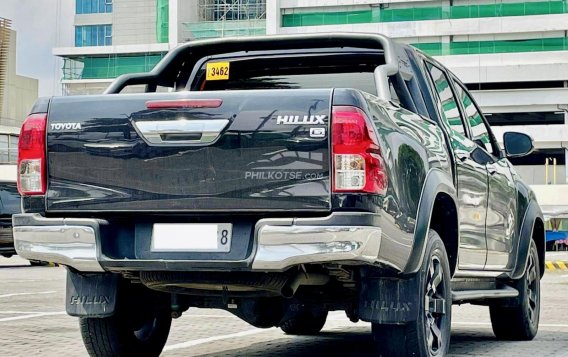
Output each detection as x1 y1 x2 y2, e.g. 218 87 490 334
191 53 384 95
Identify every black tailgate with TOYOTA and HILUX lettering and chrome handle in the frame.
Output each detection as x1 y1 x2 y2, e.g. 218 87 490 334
46 89 332 212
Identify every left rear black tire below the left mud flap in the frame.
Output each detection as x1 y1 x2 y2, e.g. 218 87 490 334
79 311 172 357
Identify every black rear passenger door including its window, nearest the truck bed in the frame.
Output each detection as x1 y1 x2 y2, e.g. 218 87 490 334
426 62 488 270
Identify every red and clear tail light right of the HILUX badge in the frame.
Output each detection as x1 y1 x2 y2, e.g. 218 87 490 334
331 106 388 194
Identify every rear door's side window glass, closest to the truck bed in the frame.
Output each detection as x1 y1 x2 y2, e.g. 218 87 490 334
426 62 466 137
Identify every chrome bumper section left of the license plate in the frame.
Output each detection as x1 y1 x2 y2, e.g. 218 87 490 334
14 225 104 272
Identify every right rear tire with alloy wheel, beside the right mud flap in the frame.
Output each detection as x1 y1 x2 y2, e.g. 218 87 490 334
372 230 452 357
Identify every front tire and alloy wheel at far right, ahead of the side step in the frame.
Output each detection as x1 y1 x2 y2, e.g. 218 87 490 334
489 240 540 341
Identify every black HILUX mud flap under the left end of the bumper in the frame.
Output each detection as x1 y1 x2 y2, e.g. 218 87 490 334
65 270 120 317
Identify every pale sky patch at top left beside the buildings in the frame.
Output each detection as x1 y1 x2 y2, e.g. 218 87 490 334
0 0 75 97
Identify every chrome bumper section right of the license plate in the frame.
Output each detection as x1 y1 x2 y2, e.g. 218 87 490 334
252 222 381 271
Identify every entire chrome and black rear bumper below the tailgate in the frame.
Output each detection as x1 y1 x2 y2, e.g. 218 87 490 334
13 213 386 272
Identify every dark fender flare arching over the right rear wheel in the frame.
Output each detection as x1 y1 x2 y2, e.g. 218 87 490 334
402 168 459 274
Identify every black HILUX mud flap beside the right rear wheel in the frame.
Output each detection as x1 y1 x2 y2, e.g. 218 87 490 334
359 277 420 324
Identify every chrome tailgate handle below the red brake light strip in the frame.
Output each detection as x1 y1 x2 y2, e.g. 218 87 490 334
134 119 229 146
